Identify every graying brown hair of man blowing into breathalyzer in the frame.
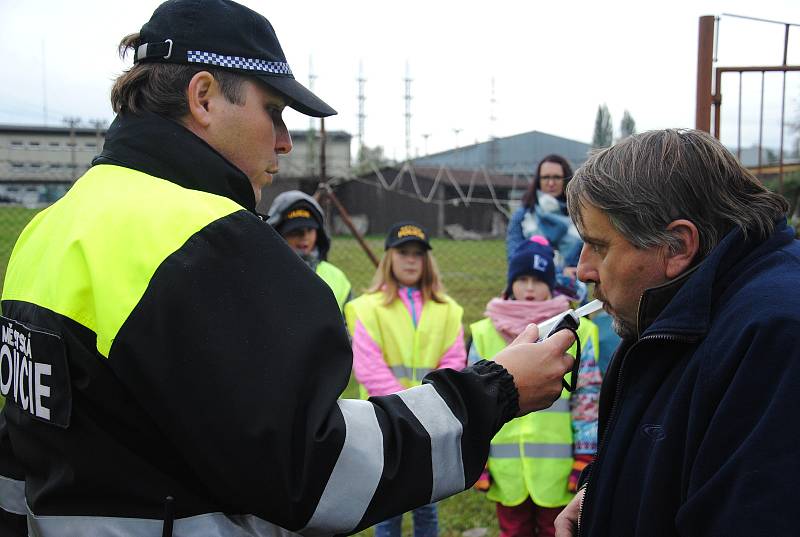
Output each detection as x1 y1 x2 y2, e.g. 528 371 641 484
567 129 789 259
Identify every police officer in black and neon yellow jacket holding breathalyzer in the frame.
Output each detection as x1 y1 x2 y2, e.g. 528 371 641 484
0 0 573 537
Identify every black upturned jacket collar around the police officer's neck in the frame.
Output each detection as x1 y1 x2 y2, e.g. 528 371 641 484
92 112 256 212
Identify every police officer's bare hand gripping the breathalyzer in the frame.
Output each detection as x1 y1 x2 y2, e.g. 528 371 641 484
494 324 575 416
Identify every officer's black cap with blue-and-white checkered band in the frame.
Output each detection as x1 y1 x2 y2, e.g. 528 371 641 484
133 0 336 117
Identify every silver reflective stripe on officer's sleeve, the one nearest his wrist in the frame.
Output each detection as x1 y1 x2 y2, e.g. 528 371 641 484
397 384 466 502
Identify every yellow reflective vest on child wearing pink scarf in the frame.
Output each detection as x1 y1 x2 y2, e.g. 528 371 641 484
470 319 598 507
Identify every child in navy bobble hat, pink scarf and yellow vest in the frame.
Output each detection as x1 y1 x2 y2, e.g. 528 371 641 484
469 236 601 537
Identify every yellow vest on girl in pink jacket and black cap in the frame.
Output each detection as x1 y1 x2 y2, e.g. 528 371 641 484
345 292 464 396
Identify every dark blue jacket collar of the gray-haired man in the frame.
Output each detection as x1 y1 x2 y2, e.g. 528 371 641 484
637 220 794 337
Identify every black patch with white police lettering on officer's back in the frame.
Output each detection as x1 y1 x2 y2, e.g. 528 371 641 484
0 315 72 428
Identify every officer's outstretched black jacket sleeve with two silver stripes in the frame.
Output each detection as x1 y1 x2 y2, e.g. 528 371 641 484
108 211 518 535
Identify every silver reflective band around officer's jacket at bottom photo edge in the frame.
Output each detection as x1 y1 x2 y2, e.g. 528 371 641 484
28 512 297 537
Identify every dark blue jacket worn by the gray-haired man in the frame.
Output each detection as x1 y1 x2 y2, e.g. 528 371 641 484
579 222 800 537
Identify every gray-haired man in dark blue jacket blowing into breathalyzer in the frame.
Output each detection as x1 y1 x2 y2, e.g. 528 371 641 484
557 130 800 537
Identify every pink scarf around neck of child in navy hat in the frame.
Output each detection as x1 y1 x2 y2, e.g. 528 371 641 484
484 296 569 343
